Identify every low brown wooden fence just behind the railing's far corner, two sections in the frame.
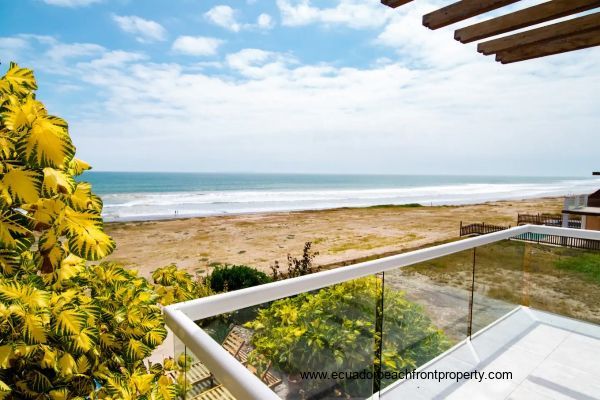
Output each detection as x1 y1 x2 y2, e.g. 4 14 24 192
460 221 600 250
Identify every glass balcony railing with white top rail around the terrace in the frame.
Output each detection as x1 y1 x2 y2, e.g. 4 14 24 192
165 226 600 399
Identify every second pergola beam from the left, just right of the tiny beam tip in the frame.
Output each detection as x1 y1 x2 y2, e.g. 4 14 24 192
423 0 520 29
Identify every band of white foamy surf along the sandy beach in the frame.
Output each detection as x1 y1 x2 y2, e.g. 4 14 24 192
102 179 600 220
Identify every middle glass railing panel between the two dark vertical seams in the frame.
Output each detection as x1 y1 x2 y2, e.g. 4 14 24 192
381 250 473 392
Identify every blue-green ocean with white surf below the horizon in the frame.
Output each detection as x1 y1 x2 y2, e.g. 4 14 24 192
80 171 600 221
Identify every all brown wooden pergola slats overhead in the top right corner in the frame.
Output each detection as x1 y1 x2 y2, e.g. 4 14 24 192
381 0 600 64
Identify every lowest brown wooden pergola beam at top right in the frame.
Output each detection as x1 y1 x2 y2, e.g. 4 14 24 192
496 29 600 64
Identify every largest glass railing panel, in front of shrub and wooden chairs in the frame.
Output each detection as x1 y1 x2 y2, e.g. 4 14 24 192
197 276 381 399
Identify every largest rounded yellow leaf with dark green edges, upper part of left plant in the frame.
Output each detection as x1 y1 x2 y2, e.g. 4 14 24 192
17 116 75 169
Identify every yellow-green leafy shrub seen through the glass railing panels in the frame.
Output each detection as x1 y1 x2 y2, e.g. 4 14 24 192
246 277 450 398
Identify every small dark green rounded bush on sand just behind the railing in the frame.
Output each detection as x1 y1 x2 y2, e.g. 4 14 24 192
209 265 271 292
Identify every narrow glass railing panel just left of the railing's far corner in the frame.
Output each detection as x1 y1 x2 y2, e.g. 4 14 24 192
471 240 528 335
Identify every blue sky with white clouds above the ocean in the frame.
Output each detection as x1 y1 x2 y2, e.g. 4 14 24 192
0 0 600 176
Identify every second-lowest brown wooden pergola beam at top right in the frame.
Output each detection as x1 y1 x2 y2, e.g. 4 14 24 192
477 12 600 55
